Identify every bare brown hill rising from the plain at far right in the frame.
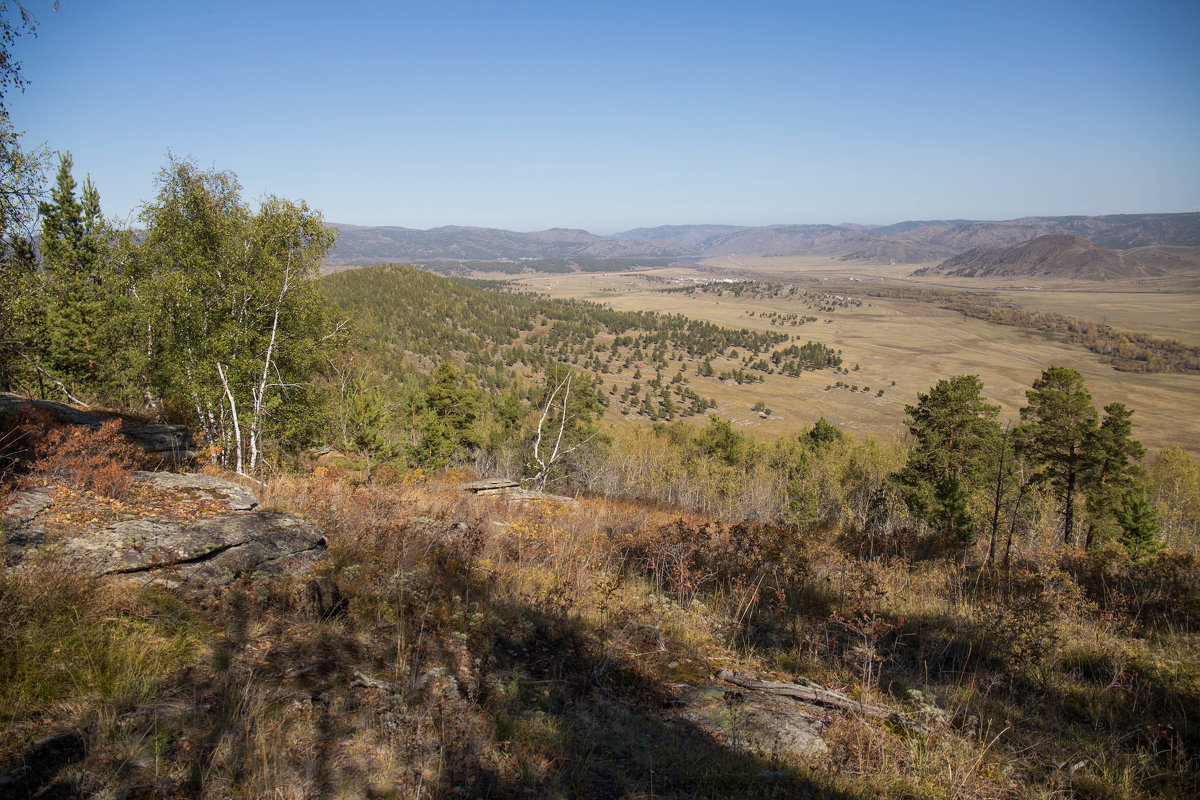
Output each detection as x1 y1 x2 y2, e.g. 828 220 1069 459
916 234 1200 281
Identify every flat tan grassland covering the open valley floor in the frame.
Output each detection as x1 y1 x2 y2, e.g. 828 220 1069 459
504 257 1200 453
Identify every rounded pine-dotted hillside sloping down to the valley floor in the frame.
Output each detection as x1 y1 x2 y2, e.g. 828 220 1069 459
322 266 841 431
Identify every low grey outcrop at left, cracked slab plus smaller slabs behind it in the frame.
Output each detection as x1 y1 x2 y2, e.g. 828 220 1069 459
2 473 326 585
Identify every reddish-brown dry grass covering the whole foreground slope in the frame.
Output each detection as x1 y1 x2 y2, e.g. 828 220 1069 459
0 468 1200 799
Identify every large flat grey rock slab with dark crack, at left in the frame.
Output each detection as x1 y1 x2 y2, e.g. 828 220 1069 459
53 511 325 584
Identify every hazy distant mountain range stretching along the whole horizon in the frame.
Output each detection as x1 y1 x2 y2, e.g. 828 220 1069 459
329 212 1200 266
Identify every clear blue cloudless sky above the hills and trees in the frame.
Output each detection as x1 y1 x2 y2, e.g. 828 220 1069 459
8 0 1200 234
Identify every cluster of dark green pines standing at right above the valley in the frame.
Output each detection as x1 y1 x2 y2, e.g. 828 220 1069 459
896 366 1159 560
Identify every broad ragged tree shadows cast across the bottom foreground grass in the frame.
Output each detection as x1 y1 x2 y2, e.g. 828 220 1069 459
159 575 852 800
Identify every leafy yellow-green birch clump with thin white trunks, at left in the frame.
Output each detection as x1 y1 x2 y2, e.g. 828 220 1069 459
140 158 340 474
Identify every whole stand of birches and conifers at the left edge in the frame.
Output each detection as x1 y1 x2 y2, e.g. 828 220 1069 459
0 154 341 471
